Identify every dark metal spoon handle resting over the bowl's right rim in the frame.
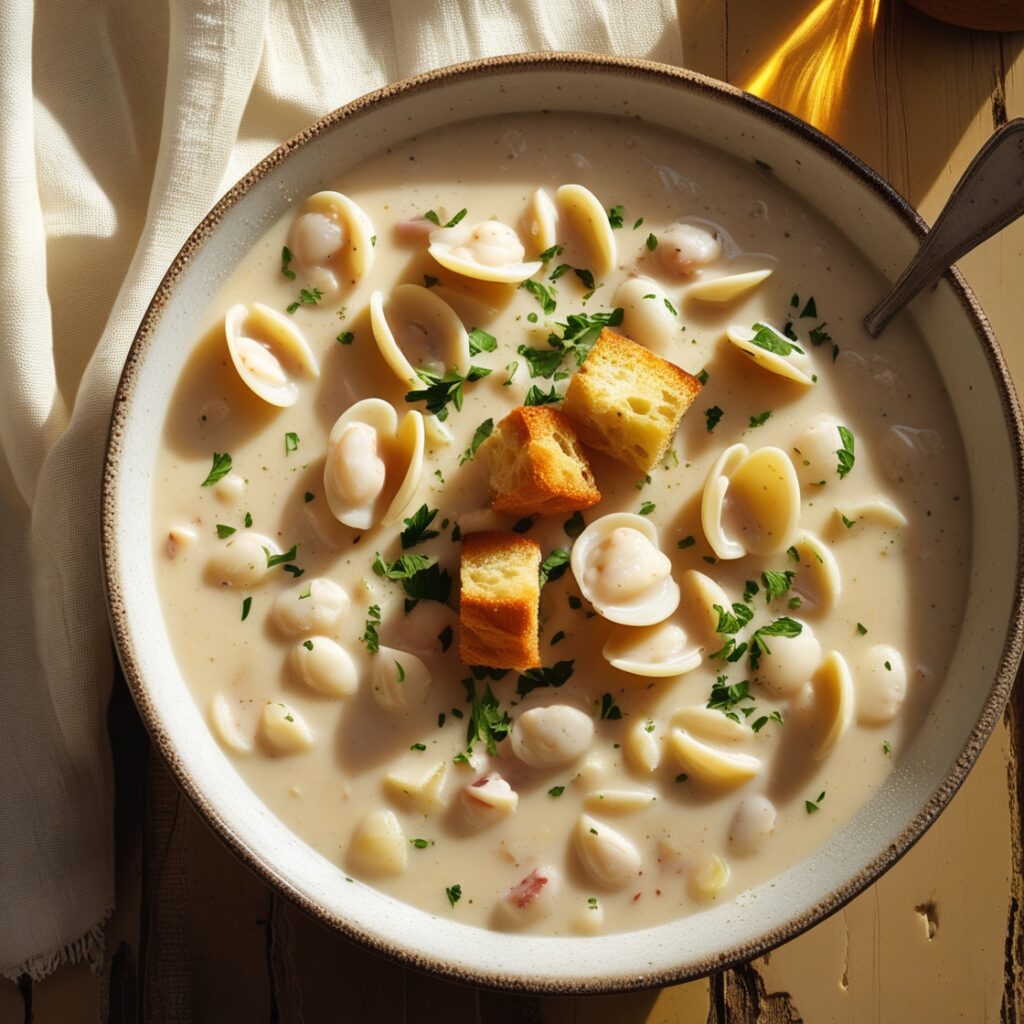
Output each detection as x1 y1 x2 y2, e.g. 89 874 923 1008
864 118 1024 338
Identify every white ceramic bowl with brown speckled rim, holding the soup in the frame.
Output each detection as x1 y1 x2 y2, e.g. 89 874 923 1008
102 53 1022 992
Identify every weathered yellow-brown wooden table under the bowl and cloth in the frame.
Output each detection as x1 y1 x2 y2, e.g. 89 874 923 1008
6 0 1024 1024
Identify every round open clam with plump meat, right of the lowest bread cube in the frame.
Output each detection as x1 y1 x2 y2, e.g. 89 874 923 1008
569 512 679 626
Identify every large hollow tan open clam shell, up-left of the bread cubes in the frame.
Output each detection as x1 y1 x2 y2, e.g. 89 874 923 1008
370 285 469 388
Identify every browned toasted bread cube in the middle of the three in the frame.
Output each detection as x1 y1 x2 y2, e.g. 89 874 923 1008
480 406 601 515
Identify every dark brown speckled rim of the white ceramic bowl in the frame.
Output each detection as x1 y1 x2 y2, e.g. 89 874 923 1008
101 53 1024 994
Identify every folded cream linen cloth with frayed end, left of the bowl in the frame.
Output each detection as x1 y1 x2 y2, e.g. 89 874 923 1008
0 0 681 979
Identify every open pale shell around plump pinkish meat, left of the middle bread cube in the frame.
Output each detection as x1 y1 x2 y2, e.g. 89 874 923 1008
324 398 424 529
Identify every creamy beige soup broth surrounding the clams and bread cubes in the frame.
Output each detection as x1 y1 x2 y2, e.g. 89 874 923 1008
153 114 970 934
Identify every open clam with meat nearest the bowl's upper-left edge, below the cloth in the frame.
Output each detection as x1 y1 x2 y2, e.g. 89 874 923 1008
288 191 375 298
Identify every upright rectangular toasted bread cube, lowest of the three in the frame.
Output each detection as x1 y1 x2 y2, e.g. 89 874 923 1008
459 531 541 669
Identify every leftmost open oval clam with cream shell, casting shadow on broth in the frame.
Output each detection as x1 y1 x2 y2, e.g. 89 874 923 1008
224 302 319 408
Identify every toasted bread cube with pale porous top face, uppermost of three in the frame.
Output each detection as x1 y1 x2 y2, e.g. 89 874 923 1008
562 328 700 473
